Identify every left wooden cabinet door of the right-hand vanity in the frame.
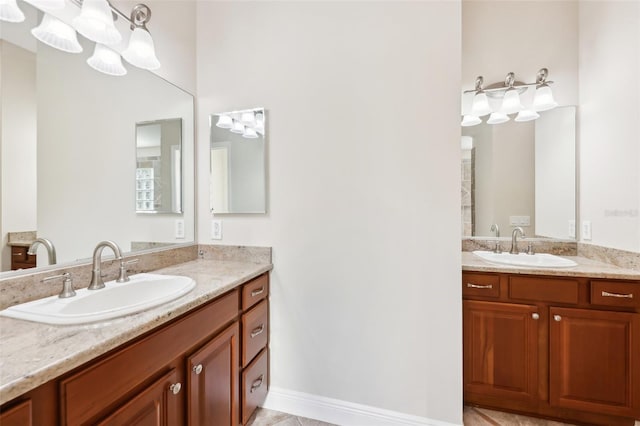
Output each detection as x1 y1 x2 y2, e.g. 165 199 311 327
463 300 540 409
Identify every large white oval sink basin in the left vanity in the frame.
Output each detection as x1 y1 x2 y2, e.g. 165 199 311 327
0 274 196 324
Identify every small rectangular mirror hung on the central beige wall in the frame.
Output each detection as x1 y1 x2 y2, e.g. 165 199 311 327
209 108 267 214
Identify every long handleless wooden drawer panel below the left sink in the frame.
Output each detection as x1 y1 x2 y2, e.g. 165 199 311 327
60 290 239 425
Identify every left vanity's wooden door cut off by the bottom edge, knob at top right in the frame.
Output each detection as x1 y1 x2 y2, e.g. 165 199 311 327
98 369 184 426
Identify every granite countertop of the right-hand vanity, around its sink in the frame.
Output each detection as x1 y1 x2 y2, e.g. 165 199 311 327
462 251 640 280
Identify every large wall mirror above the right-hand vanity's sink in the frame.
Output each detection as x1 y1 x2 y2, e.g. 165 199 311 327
461 106 576 240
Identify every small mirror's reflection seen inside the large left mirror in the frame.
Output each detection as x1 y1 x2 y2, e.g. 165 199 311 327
135 118 182 213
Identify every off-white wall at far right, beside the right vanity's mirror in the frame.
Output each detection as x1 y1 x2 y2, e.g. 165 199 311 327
578 1 640 252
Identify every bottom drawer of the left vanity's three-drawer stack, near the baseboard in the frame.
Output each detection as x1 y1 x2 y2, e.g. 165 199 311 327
242 348 269 425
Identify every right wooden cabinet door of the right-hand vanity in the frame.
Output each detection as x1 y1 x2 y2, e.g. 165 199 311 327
549 308 640 418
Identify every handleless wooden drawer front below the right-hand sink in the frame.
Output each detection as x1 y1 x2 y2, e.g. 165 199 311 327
509 277 578 303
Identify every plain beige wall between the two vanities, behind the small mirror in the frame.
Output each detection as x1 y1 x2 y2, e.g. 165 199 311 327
197 1 462 424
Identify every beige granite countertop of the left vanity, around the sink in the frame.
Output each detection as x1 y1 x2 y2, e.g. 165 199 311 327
0 259 272 404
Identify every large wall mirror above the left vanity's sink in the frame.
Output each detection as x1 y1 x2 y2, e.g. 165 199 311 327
0 0 195 273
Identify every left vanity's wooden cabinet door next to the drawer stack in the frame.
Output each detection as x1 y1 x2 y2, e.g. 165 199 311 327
186 322 240 426
